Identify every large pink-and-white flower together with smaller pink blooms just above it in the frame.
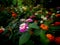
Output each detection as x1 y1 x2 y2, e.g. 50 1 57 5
19 18 33 32
